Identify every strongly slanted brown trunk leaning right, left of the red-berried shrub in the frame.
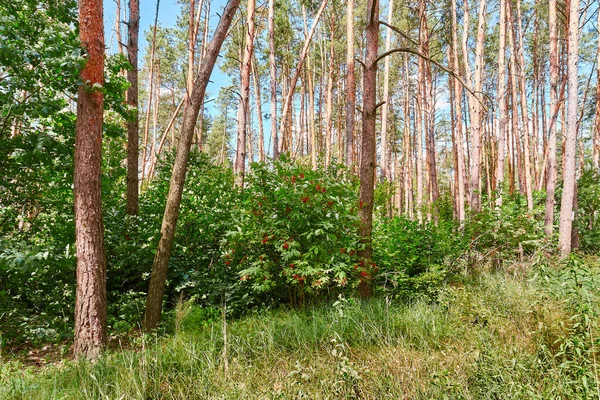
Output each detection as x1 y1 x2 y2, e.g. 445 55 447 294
143 0 240 331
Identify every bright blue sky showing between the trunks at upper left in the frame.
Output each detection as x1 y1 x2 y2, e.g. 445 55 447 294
104 0 230 119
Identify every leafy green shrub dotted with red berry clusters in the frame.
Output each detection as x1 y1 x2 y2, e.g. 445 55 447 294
226 157 366 304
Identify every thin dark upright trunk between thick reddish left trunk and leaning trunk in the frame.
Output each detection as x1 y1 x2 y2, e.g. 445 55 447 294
127 0 140 215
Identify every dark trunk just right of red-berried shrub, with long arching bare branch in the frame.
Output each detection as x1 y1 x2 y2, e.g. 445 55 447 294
358 0 379 298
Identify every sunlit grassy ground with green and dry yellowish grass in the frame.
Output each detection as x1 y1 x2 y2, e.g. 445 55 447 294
0 258 600 399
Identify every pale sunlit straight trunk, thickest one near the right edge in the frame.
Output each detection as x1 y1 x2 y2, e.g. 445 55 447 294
558 0 579 258
